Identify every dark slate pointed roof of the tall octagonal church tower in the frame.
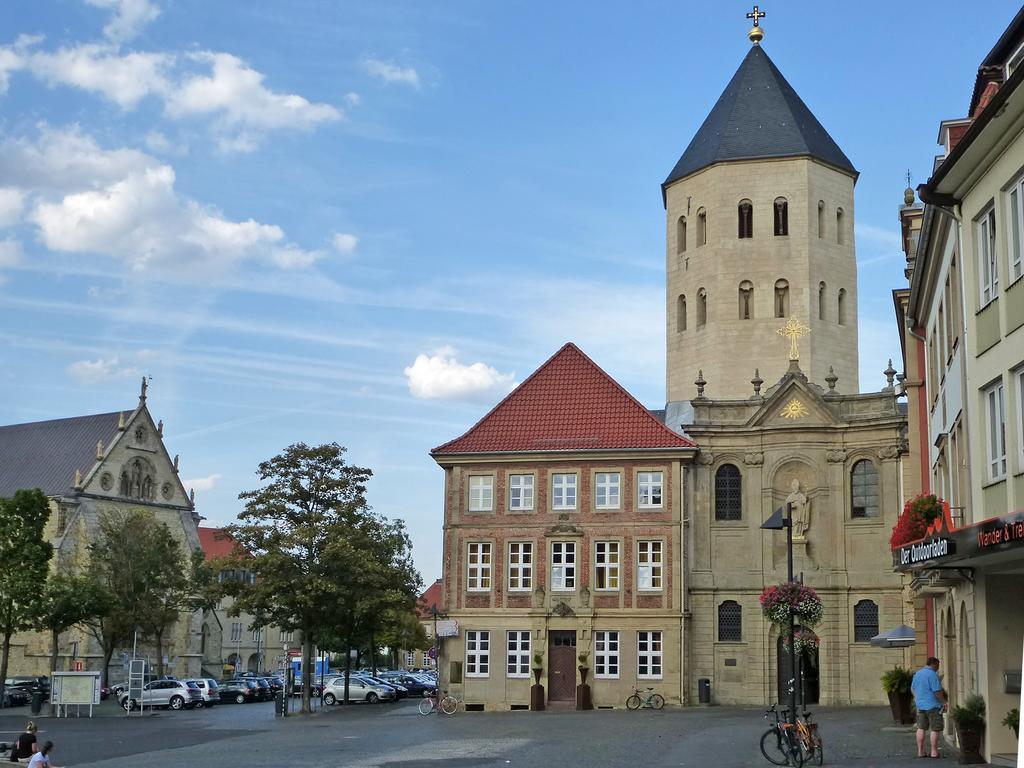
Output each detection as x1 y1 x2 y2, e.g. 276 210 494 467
662 45 857 189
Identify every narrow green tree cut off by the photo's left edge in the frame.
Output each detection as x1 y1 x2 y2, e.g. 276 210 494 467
0 489 53 697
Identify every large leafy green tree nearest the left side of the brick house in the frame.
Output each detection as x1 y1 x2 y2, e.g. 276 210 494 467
228 443 419 713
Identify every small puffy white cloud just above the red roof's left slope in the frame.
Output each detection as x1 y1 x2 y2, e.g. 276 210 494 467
404 347 516 400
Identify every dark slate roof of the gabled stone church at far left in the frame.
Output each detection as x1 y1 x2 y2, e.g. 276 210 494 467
0 411 121 499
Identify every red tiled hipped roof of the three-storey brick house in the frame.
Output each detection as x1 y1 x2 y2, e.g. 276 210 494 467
431 343 695 456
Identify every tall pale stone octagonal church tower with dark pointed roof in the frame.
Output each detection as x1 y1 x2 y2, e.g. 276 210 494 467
662 27 859 401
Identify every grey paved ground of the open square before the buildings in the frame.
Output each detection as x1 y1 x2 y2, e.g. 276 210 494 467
0 701 991 768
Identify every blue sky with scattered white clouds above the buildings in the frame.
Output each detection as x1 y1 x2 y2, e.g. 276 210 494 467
0 0 1014 583
